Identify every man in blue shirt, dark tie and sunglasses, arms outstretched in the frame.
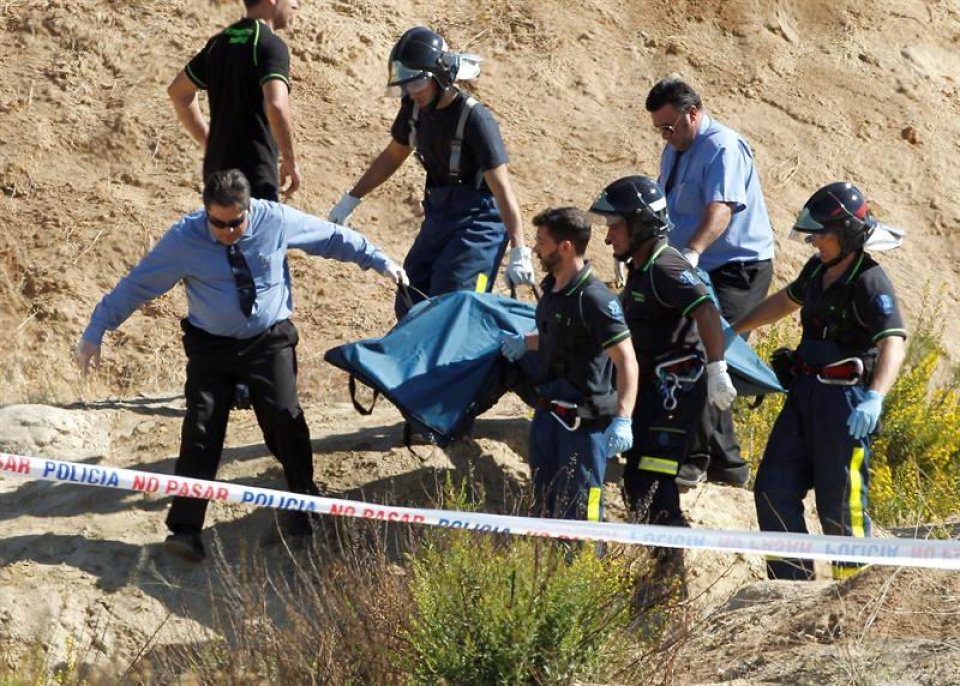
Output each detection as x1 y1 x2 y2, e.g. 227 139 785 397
76 169 407 561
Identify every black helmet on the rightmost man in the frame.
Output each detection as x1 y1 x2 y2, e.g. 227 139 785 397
793 181 877 262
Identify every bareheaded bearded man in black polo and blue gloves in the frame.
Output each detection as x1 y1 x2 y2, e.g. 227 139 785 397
501 207 637 521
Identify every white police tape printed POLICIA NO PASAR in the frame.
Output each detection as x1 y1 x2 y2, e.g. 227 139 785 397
0 453 960 570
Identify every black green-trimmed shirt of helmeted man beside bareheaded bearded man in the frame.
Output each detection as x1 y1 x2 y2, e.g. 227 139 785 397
620 239 711 371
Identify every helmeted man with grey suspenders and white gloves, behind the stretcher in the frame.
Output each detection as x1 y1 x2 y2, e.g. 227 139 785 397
328 27 534 318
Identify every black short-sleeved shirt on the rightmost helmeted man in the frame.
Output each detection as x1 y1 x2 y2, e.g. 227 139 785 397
787 253 907 364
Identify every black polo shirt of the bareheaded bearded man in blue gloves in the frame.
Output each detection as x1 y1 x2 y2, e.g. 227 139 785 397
536 264 630 398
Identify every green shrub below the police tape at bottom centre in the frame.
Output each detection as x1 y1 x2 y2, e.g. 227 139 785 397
406 532 631 685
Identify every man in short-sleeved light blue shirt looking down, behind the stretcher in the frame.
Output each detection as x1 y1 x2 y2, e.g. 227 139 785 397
646 79 773 487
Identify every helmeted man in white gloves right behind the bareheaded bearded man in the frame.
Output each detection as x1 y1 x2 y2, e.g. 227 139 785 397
590 176 737 525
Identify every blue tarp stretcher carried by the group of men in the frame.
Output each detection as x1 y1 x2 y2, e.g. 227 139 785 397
324 291 782 446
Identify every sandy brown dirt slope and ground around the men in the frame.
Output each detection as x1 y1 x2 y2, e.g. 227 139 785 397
0 0 960 683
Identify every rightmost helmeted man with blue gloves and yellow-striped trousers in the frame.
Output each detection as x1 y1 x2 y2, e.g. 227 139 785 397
734 182 907 580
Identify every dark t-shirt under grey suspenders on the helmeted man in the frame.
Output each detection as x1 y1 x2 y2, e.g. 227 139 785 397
390 93 510 188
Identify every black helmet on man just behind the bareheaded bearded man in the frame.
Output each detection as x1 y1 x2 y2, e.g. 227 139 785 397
590 176 672 252
